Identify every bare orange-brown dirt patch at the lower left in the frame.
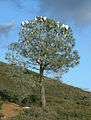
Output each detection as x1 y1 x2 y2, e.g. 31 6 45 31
0 103 22 120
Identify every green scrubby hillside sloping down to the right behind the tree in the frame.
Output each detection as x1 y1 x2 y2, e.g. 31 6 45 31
0 62 91 120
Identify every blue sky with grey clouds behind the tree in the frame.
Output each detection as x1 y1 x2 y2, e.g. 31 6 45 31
0 0 91 91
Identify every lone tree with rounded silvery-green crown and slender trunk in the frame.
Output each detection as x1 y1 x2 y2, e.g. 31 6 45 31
6 16 80 106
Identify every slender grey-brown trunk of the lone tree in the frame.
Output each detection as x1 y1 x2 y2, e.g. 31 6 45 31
40 65 46 107
